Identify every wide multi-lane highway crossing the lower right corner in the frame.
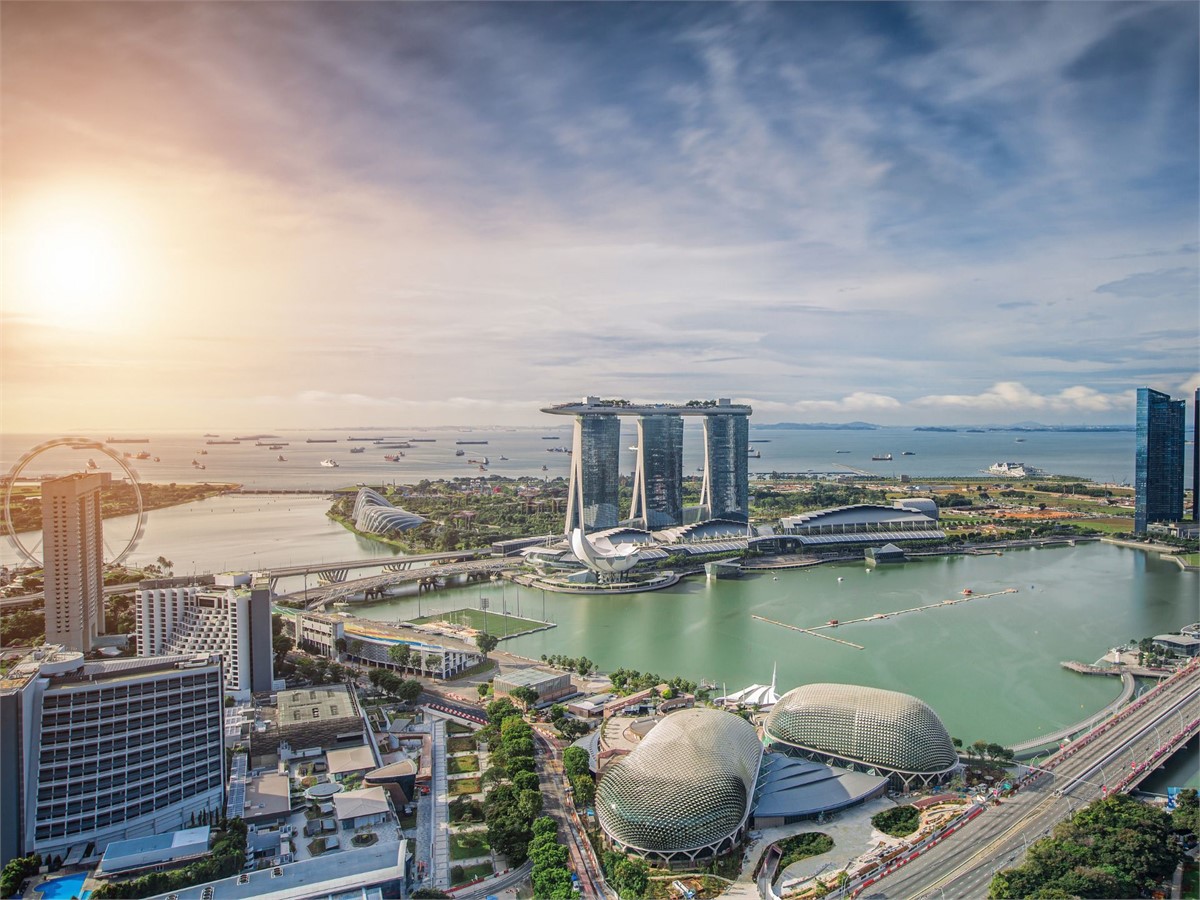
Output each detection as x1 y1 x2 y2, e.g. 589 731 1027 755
854 665 1200 900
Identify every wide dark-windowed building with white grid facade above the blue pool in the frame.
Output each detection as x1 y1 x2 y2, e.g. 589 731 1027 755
0 646 224 863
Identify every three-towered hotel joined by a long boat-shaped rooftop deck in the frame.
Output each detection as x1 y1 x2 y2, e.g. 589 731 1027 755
541 397 754 533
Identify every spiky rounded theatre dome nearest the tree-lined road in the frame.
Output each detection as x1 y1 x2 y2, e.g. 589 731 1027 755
595 709 762 864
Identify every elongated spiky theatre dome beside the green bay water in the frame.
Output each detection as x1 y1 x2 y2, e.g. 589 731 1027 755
764 684 959 790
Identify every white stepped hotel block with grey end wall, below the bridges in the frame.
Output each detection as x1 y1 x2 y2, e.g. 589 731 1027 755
136 572 275 700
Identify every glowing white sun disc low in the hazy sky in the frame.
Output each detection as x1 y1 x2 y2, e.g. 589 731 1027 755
5 195 131 328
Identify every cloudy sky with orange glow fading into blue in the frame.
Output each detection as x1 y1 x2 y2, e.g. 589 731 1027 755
0 0 1200 433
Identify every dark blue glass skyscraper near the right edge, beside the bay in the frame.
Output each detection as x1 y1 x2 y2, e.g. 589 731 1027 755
1134 388 1184 534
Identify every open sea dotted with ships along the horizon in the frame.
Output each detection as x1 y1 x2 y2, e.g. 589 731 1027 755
0 422 1161 491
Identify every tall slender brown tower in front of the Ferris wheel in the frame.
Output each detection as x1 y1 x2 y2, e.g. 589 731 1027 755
42 472 112 653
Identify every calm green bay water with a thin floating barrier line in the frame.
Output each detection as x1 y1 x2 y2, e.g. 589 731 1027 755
354 544 1200 744
